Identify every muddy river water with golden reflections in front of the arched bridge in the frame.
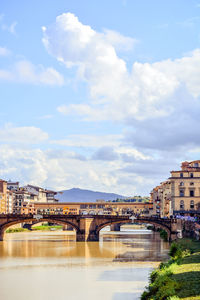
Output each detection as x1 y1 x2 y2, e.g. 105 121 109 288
0 228 168 300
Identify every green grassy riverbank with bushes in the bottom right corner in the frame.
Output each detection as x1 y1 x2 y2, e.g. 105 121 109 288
141 239 200 300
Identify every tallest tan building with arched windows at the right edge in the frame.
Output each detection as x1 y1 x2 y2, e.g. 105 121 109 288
169 160 200 215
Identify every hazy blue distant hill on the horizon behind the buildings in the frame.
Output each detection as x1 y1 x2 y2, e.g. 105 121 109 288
56 188 126 202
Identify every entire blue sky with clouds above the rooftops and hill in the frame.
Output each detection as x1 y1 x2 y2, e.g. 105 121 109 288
0 0 200 196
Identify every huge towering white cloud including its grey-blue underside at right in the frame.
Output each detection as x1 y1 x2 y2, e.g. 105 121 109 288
43 13 200 160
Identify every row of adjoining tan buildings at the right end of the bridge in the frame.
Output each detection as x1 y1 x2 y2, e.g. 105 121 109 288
151 160 200 217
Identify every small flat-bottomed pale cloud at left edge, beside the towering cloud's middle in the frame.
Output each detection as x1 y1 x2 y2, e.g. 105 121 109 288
0 60 64 86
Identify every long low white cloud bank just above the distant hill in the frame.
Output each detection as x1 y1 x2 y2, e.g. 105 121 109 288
0 145 155 195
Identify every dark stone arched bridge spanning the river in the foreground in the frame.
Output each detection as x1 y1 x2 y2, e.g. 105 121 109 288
0 214 183 242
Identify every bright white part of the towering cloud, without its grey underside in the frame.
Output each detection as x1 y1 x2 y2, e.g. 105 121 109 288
43 13 200 121
